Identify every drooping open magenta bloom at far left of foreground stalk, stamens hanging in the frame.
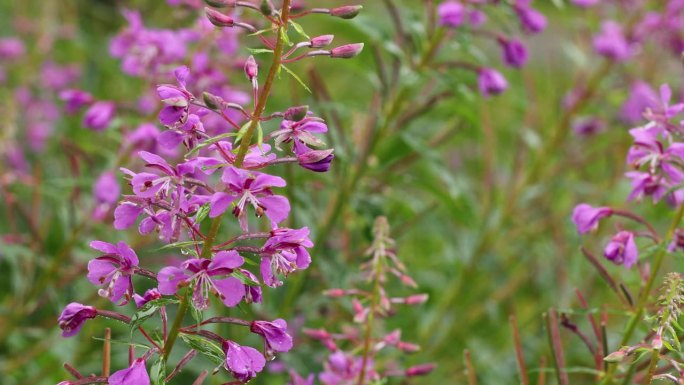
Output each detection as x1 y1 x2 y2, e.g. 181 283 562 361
88 241 138 305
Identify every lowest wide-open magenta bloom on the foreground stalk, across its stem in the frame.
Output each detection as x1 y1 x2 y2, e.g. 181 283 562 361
157 250 245 309
